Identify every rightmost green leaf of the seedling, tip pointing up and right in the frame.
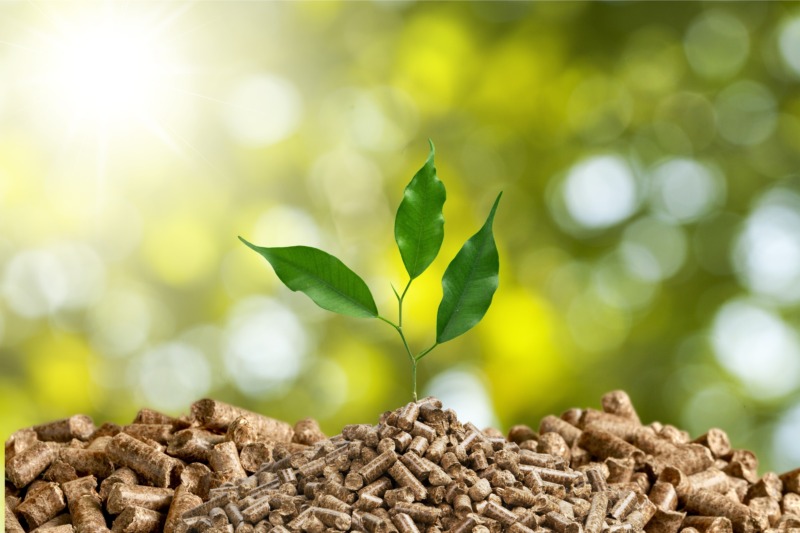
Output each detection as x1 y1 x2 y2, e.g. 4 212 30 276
436 193 503 343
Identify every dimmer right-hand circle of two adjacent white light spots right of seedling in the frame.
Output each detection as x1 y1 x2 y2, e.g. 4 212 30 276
650 159 724 223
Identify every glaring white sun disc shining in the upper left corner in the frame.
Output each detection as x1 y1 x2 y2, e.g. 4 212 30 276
48 13 180 126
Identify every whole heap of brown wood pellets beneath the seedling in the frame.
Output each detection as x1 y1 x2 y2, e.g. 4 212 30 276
6 391 800 533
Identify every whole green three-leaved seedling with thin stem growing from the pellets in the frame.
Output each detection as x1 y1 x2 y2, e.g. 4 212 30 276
239 142 503 401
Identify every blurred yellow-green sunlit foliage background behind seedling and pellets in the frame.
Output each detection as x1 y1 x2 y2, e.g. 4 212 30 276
0 1 800 478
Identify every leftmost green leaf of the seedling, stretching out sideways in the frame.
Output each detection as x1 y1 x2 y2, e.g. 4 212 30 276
239 237 378 318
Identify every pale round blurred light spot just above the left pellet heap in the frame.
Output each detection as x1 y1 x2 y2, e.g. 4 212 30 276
138 342 211 412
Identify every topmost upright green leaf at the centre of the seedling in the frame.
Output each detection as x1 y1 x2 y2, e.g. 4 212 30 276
394 141 447 279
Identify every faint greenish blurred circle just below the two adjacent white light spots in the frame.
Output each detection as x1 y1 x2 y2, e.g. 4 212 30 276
620 218 687 282
